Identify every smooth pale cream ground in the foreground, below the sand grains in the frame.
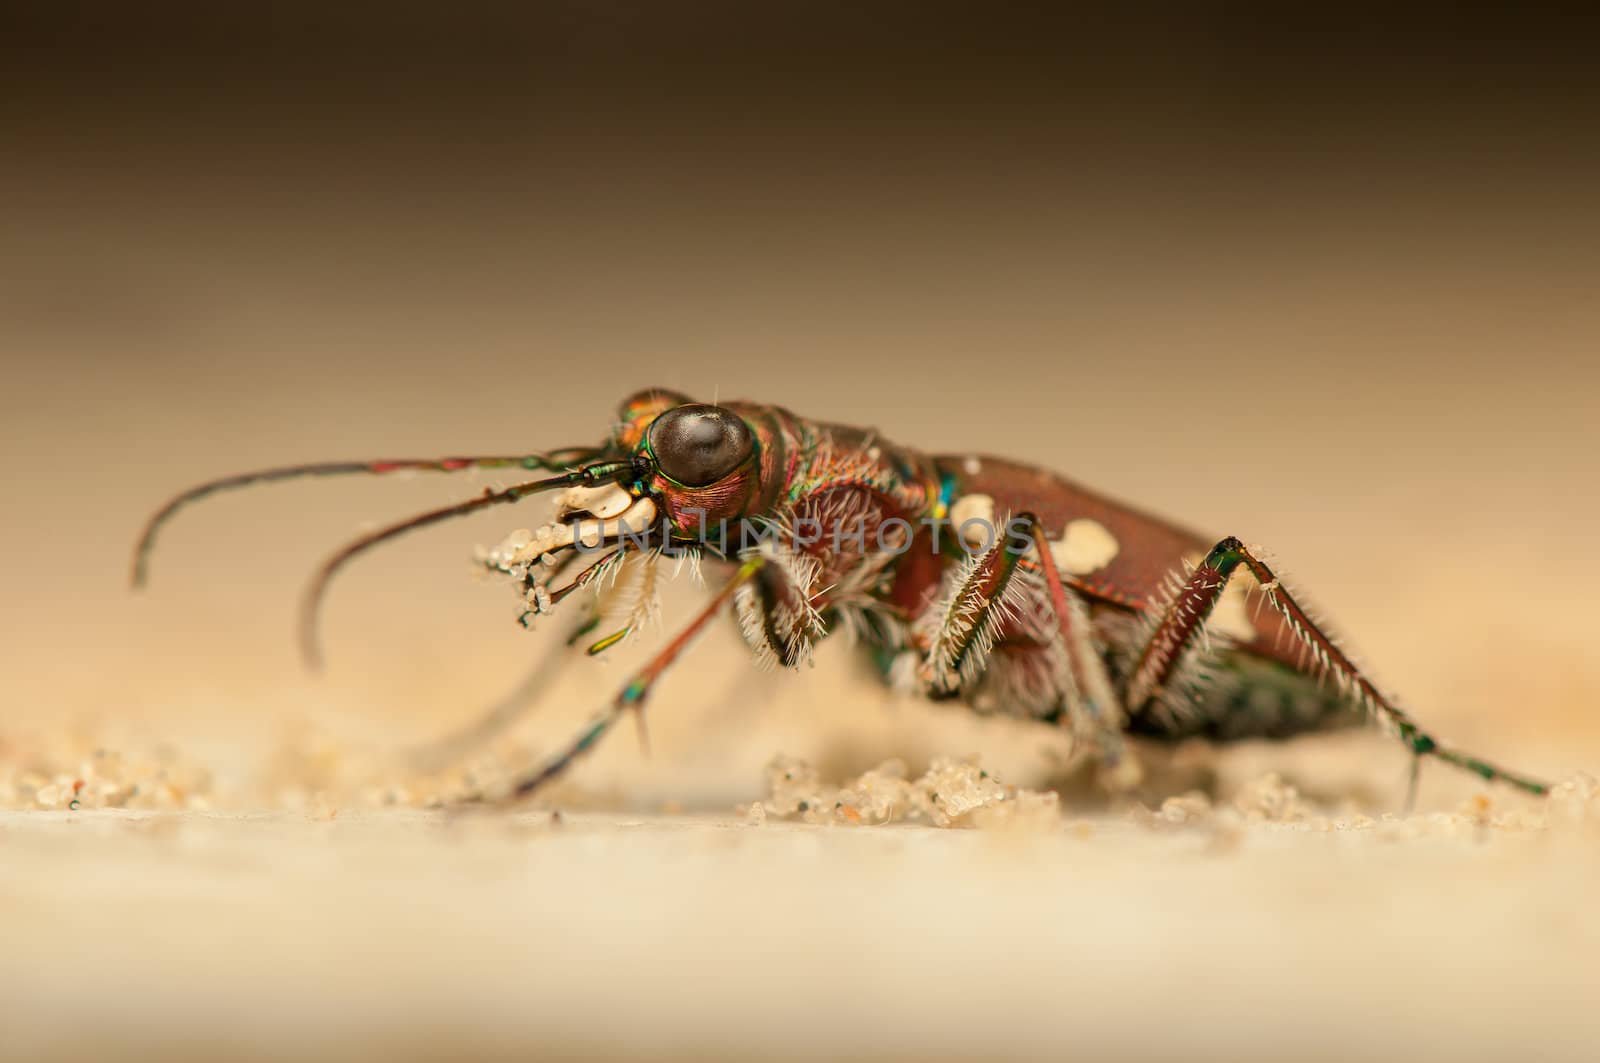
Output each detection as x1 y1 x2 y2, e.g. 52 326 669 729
9 797 1600 1060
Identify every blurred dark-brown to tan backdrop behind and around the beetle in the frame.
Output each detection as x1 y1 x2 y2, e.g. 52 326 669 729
0 3 1600 807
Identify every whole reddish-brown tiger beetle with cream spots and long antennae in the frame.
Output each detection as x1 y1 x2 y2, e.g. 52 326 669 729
133 391 1547 797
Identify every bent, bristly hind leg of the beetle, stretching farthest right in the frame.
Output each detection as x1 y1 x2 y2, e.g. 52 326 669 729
1125 536 1549 794
